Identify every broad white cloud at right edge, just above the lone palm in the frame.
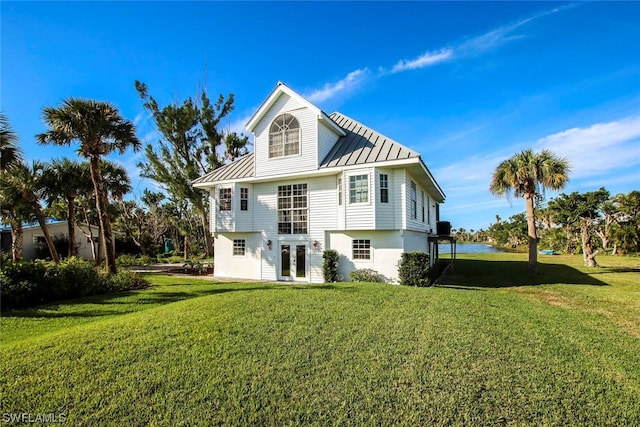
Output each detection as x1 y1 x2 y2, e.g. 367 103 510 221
536 116 640 179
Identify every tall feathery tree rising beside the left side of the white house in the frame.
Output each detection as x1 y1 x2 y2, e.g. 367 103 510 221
135 81 249 256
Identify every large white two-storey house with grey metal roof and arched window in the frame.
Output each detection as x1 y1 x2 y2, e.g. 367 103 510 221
193 83 445 283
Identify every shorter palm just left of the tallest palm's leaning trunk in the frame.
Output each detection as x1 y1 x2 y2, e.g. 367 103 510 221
42 158 92 257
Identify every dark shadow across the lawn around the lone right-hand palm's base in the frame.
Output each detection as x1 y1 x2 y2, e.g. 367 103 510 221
436 259 608 290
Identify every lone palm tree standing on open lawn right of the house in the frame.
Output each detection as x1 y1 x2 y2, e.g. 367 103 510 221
489 149 570 275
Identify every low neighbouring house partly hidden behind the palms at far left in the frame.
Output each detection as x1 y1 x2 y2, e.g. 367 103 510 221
2 220 99 261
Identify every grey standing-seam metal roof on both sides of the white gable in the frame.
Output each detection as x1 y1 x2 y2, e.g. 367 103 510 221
192 112 420 184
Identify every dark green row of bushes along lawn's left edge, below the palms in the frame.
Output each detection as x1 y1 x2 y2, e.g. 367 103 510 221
0 258 147 309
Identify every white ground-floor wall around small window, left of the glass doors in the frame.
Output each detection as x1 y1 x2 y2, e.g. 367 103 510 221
214 233 262 279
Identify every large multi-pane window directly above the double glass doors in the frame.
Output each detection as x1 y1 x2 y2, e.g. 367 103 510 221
278 184 308 234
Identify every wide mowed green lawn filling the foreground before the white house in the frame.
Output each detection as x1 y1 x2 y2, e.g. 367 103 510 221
0 254 640 426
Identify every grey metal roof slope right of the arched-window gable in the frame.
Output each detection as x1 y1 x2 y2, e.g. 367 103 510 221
320 112 420 168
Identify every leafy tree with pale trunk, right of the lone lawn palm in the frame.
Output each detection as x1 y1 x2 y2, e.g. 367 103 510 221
548 187 609 267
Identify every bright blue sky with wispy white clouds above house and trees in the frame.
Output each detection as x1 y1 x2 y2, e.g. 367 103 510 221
0 1 640 230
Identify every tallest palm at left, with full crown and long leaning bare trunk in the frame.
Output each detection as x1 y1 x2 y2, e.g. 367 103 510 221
37 98 140 273
